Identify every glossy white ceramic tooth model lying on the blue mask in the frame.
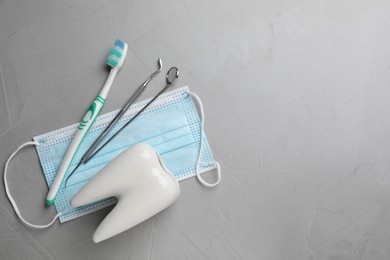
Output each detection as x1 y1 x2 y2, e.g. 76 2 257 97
71 144 180 243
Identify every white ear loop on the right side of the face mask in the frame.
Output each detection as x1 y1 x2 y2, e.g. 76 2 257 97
189 92 221 188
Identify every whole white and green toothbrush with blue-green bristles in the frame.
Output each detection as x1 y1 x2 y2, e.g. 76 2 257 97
45 40 128 206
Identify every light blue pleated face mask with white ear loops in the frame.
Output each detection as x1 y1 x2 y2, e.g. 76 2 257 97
4 87 221 228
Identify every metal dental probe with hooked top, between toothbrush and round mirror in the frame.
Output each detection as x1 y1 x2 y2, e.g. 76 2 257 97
78 59 162 165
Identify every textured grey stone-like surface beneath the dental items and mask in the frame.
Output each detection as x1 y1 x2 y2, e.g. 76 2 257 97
0 0 390 260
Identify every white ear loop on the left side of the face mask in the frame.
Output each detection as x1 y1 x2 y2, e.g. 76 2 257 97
4 142 63 229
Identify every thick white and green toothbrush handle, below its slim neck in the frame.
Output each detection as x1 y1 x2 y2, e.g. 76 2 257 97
46 95 105 205
